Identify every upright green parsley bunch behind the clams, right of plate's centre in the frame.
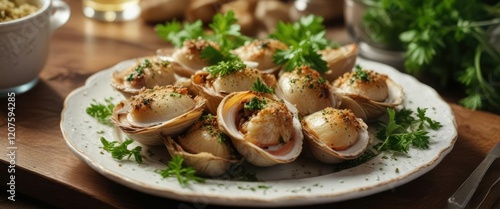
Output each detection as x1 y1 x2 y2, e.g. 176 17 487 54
269 15 337 72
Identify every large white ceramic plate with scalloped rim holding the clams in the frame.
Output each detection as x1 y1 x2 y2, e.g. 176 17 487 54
61 58 457 207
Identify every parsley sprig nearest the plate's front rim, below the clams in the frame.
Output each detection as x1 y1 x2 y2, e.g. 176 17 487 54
157 155 205 186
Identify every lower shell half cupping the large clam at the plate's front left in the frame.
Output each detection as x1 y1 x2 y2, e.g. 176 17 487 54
111 85 206 145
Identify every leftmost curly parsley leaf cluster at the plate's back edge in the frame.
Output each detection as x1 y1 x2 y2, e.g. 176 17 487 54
155 20 205 47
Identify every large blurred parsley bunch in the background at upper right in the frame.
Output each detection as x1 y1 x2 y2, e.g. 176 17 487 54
362 0 500 112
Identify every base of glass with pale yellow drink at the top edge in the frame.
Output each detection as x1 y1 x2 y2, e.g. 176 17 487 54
83 0 141 22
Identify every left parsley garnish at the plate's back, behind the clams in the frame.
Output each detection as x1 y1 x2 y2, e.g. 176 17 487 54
155 11 250 64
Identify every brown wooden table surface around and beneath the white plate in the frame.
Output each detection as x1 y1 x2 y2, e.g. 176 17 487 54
0 0 500 209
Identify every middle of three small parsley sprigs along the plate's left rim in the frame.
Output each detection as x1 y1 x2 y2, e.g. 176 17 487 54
101 137 142 163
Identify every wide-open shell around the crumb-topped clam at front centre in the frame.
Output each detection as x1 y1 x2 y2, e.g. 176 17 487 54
217 91 303 166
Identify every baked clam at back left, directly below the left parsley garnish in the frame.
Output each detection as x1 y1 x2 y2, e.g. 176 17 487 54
156 39 219 78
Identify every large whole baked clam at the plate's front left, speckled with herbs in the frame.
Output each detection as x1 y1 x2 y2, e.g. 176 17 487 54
111 86 206 145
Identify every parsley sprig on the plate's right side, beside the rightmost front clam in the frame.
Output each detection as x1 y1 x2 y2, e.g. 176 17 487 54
374 108 442 153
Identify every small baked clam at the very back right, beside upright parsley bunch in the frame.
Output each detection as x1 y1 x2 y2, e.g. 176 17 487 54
319 44 358 81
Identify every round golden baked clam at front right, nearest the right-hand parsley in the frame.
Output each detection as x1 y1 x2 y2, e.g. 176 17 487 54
301 107 369 163
